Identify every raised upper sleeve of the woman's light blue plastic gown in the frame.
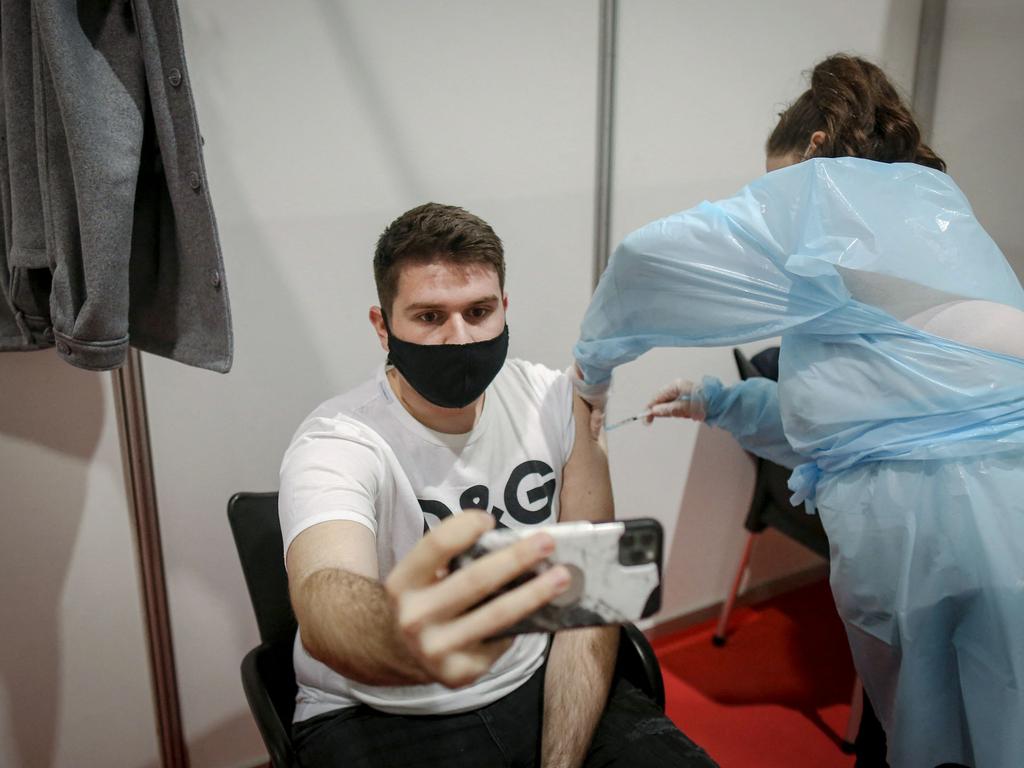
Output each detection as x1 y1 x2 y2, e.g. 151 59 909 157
573 168 849 383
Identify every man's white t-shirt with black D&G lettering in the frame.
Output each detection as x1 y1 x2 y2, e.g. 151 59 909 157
280 359 575 722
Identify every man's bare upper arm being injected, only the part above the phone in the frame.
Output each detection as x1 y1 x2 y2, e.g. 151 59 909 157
558 394 614 522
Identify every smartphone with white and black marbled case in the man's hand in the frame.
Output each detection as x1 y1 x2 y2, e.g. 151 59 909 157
451 518 662 637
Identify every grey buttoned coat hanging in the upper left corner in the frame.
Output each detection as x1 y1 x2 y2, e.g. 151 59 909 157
0 0 232 372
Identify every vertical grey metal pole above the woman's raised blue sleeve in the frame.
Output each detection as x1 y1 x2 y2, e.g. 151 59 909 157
593 0 618 287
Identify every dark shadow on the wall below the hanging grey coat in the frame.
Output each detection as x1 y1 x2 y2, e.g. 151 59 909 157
0 350 106 768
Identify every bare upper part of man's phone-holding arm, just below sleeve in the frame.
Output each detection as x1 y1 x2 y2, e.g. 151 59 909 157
285 520 380 596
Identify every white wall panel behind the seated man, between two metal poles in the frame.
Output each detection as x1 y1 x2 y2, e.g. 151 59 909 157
144 0 598 768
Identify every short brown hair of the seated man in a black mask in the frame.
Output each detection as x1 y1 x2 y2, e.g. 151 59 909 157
374 203 505 314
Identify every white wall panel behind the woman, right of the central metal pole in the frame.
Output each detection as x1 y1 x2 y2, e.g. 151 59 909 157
608 0 920 622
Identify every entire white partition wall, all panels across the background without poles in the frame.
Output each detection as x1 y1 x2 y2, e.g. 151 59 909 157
0 0 1024 768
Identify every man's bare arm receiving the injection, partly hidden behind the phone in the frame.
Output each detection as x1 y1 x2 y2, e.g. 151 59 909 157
542 396 620 768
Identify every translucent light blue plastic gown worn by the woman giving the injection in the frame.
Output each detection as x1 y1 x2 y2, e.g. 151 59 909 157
574 158 1024 768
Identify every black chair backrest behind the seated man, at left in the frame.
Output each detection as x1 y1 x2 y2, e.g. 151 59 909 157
227 493 296 645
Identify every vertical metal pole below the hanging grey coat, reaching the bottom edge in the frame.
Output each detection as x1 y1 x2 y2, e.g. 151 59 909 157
113 349 188 768
